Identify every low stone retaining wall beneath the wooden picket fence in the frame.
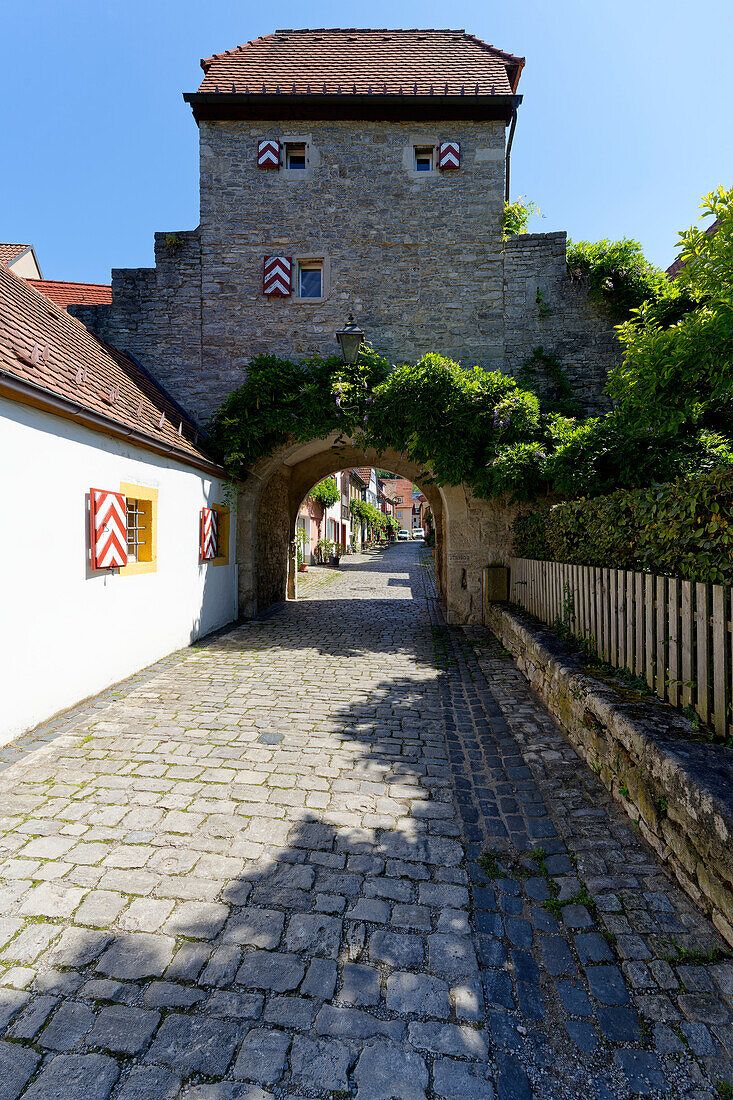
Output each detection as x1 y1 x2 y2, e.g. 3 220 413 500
486 604 733 945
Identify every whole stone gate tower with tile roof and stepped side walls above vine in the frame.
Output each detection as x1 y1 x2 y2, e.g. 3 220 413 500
75 30 616 418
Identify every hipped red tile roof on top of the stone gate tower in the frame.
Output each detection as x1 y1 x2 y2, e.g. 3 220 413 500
198 28 524 96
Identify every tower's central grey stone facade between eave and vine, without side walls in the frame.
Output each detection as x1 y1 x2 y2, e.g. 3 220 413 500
191 113 504 418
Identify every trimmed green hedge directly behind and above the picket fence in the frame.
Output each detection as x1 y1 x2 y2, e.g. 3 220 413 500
514 466 733 584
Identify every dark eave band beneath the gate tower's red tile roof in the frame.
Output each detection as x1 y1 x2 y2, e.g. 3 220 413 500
184 91 522 123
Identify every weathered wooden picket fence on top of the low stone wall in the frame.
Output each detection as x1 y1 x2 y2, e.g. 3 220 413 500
510 558 733 737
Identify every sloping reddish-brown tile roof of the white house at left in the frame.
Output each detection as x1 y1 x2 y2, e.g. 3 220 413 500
0 264 212 475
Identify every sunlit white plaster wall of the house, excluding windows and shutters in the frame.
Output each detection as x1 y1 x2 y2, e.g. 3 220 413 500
0 398 237 745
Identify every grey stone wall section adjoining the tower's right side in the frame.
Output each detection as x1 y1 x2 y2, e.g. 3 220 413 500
504 232 621 416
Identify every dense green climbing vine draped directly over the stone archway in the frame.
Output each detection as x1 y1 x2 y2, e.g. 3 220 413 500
211 349 541 495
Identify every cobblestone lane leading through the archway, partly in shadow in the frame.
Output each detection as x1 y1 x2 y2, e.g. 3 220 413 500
0 545 733 1100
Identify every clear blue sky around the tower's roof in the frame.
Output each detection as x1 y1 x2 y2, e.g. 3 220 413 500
0 0 733 282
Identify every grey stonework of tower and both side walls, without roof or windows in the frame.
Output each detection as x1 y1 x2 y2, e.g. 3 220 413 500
72 130 620 420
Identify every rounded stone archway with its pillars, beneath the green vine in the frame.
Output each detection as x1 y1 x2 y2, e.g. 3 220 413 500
237 435 516 623
